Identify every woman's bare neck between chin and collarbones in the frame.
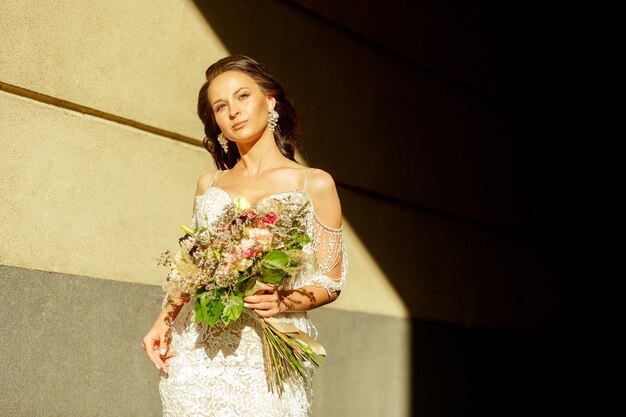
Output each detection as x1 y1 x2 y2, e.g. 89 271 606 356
234 129 286 176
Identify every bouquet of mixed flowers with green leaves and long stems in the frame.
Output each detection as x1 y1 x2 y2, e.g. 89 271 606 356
157 197 325 393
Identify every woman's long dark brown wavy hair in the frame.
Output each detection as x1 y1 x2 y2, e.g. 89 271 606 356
198 55 300 169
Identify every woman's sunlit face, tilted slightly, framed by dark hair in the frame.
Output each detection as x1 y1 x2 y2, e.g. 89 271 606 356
208 71 276 146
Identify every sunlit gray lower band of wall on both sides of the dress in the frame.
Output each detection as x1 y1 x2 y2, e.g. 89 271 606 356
0 266 410 417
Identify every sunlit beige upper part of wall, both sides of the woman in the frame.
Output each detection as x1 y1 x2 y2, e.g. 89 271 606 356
0 1 405 316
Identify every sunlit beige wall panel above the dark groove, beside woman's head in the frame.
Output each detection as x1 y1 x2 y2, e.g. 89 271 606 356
0 0 227 139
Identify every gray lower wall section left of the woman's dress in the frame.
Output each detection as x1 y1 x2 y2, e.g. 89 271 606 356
0 266 161 417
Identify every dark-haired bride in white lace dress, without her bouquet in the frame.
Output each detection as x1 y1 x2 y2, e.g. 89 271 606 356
142 56 347 417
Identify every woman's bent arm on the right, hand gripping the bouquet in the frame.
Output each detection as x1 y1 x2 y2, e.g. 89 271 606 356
244 169 347 317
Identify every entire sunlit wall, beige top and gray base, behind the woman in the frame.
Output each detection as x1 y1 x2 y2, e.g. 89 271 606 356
0 0 411 416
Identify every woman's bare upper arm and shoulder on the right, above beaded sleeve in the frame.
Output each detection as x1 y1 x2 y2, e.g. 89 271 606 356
306 169 341 228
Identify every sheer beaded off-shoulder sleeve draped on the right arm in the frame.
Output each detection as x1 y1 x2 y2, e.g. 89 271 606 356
304 217 348 295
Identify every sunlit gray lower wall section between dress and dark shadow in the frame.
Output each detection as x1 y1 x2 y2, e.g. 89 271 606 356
310 308 411 417
